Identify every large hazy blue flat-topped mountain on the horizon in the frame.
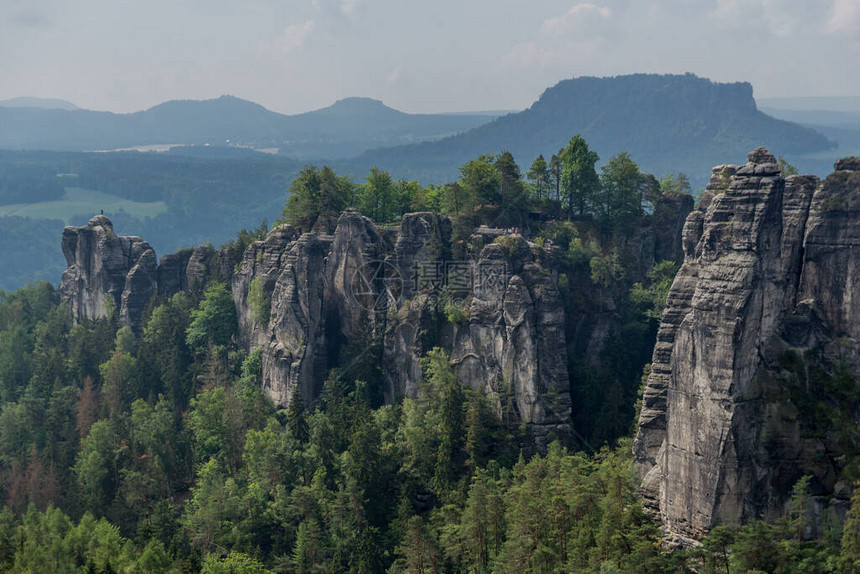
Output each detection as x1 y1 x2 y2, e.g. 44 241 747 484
355 74 834 183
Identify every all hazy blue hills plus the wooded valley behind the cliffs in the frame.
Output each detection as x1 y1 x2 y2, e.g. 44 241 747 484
0 74 832 289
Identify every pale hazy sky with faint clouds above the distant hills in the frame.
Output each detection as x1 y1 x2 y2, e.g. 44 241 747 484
0 0 860 114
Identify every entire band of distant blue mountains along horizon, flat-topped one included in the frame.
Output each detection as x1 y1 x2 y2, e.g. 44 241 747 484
0 74 848 185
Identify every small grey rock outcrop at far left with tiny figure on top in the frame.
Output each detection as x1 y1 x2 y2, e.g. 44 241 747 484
60 215 158 330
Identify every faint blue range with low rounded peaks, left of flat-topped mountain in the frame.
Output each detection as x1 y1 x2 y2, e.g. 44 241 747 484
0 96 494 159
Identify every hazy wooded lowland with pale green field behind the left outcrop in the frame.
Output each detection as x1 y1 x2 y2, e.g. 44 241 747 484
0 148 301 289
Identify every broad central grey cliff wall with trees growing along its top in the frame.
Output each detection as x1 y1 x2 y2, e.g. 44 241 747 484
233 210 570 440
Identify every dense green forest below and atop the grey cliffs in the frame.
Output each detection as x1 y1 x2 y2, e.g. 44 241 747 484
0 136 860 573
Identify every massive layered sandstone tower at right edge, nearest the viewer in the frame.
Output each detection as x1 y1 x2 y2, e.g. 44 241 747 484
634 152 860 544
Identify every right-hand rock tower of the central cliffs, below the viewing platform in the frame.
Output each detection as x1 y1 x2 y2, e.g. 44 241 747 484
451 239 571 447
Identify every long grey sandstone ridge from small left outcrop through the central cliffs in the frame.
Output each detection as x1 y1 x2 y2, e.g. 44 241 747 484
61 202 689 448
